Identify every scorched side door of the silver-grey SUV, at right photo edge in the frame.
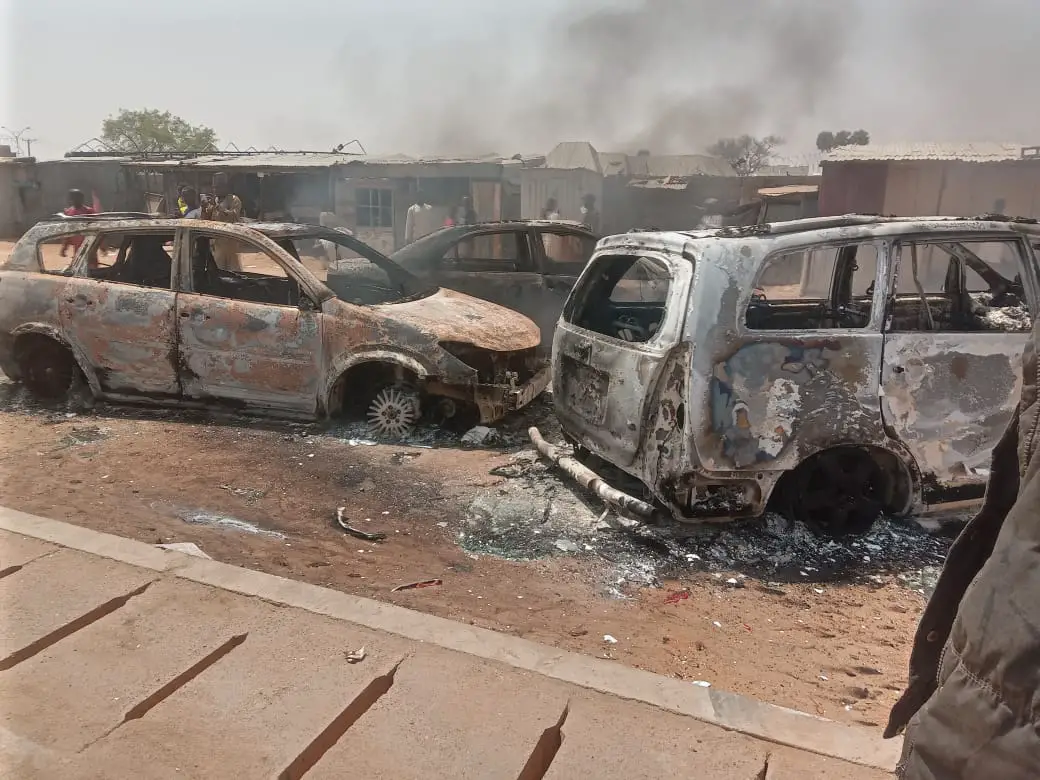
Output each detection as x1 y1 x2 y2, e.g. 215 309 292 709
881 233 1038 503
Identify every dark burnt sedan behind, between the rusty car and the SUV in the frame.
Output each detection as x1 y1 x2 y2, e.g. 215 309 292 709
329 219 597 353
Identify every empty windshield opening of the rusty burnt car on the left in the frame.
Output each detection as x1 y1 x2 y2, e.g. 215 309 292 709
275 230 437 306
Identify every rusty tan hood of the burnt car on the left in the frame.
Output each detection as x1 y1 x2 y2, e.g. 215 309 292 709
369 289 542 352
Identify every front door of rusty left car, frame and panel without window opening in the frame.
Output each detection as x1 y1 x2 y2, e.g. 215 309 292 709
177 223 332 418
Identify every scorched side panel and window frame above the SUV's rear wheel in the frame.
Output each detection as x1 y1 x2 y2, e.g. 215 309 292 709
687 236 888 473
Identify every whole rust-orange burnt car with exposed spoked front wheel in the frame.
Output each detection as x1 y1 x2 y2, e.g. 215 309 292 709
0 214 548 436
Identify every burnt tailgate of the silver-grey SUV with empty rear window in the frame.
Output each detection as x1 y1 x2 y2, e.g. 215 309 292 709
552 250 693 467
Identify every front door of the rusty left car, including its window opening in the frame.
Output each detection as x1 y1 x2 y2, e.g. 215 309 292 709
177 229 321 415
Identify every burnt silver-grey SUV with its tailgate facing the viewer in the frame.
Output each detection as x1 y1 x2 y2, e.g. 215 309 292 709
531 215 1040 535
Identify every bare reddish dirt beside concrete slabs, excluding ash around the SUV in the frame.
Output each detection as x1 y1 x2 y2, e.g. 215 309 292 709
0 411 924 726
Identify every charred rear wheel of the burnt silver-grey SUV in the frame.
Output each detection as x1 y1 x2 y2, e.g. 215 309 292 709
787 447 890 538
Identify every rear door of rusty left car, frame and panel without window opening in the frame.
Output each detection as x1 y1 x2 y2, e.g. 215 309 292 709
58 224 181 402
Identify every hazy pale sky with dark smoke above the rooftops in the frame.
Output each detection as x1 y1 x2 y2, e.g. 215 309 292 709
0 0 1040 157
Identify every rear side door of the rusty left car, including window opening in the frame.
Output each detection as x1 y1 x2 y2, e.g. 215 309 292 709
58 228 180 398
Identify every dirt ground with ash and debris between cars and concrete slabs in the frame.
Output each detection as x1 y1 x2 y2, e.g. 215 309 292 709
0 368 946 727
